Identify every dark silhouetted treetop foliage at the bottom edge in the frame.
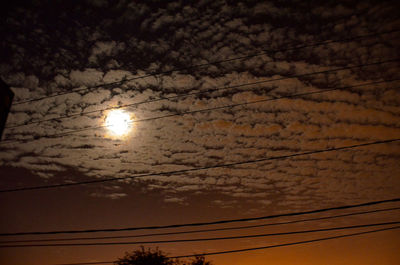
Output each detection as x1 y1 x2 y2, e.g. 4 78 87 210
114 247 213 265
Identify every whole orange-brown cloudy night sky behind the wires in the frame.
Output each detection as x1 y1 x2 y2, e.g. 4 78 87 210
0 0 400 265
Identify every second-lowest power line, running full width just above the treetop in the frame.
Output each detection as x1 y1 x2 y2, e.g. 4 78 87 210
0 221 400 248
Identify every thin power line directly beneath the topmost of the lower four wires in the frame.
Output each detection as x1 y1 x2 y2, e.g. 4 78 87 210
0 207 400 244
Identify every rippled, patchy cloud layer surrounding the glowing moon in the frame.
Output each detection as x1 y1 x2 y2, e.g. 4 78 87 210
0 1 400 208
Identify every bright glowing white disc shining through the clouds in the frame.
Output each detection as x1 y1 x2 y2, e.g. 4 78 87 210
105 110 132 136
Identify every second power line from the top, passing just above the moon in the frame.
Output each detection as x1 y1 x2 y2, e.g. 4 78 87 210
5 59 399 130
